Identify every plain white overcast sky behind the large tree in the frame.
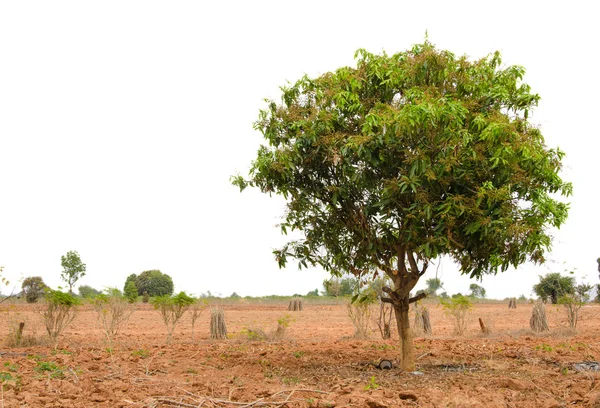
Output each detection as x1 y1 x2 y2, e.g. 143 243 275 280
0 0 600 298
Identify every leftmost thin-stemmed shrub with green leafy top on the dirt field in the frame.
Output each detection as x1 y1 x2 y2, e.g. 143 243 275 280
41 290 80 345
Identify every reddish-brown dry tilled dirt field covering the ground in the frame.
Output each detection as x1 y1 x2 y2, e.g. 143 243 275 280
0 303 600 407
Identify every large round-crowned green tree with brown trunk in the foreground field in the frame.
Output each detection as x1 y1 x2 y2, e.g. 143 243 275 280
232 41 571 370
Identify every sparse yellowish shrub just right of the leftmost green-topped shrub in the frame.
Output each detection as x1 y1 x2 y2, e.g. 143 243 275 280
93 289 134 345
